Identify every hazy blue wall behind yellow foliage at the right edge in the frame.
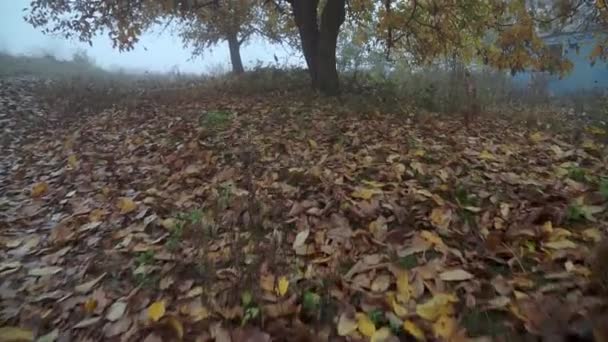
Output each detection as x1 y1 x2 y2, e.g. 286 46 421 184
513 34 608 95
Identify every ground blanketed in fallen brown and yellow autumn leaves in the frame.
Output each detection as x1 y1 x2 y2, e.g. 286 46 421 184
0 79 608 342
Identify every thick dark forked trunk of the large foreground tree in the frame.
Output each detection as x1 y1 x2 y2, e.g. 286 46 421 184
291 0 346 95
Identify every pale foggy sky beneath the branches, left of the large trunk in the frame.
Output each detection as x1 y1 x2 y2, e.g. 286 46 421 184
0 0 302 73
